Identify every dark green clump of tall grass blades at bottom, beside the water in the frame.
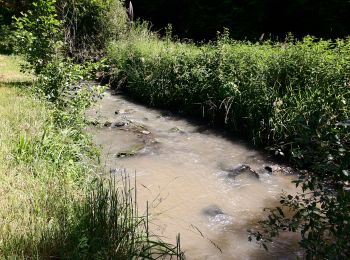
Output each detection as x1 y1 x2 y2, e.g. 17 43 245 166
64 173 184 259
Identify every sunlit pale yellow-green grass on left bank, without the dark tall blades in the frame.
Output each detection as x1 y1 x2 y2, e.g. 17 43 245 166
0 56 86 258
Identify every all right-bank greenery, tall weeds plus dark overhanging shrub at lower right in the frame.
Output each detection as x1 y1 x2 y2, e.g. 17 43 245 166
108 29 350 257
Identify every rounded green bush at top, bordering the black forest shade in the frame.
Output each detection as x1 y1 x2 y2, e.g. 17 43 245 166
57 0 127 61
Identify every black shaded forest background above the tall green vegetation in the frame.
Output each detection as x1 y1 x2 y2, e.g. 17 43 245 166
132 0 350 40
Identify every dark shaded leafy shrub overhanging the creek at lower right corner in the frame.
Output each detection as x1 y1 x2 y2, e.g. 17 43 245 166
250 121 350 259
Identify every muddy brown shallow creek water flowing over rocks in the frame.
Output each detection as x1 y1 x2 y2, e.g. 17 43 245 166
88 92 299 259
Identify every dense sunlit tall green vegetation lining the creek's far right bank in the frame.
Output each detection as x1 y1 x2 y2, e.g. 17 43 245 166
108 35 350 169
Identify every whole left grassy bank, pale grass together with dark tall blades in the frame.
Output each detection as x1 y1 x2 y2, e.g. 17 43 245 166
0 56 181 259
